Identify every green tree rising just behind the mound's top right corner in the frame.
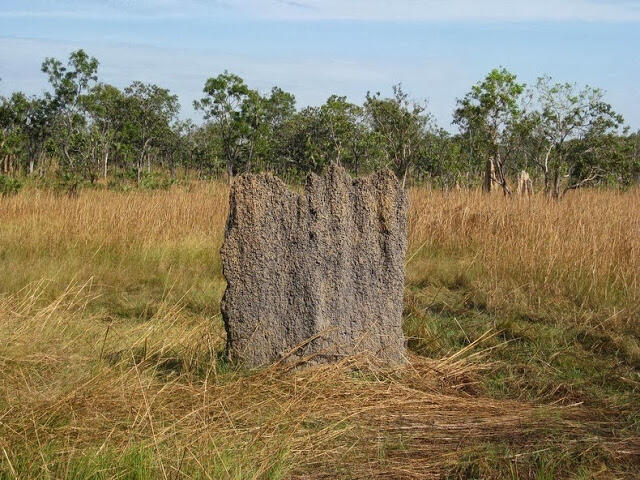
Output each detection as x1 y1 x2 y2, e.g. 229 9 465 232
364 85 433 186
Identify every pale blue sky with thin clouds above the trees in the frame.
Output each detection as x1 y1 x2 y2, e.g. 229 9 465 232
0 0 640 130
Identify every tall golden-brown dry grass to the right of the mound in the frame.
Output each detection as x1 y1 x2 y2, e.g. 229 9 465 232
409 189 640 322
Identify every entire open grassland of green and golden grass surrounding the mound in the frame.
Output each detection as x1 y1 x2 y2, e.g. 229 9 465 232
0 183 640 480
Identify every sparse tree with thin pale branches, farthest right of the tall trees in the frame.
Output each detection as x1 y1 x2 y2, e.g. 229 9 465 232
536 76 623 198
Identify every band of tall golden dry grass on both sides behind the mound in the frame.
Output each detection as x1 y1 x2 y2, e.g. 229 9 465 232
0 184 640 317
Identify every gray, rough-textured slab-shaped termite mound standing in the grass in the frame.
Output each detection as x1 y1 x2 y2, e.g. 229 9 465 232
221 165 407 366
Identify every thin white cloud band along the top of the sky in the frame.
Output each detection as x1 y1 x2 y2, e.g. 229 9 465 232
0 0 640 22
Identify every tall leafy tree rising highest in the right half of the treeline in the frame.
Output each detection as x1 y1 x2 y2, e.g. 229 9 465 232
453 68 524 195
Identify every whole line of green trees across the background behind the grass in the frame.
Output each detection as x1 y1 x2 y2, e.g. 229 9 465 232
0 50 640 196
